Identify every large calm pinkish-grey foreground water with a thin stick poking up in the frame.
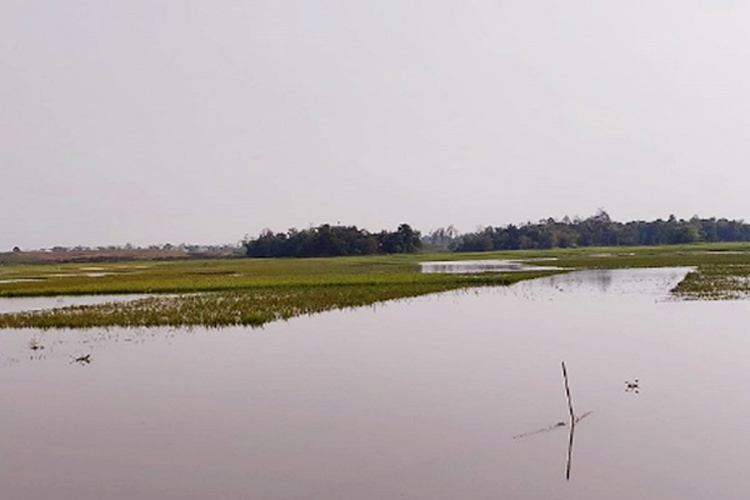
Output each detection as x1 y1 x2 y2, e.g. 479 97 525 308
0 269 750 500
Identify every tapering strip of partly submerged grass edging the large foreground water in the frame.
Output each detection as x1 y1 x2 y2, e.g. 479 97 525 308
0 272 550 328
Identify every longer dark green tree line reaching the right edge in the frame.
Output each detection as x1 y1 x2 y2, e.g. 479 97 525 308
450 210 750 252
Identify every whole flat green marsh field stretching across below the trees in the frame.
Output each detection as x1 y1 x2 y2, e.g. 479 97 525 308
0 244 750 328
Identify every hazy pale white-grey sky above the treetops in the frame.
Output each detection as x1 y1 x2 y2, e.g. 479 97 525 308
0 0 750 250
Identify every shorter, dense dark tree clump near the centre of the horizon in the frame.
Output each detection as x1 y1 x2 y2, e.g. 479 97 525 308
243 224 422 257
